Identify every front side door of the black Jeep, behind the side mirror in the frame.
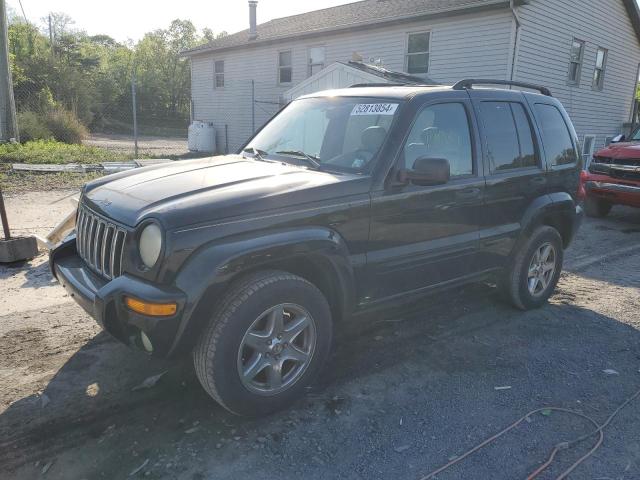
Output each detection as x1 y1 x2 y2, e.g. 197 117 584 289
364 92 484 303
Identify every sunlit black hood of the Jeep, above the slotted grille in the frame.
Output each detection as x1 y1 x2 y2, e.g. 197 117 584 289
83 155 366 229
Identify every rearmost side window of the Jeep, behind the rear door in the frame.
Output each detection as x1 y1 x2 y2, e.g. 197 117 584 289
535 103 578 166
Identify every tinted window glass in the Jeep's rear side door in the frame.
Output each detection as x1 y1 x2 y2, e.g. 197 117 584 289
480 102 538 172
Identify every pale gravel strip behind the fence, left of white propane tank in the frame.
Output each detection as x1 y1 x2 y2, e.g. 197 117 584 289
84 134 189 156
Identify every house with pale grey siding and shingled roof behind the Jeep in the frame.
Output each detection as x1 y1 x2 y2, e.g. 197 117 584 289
184 0 640 156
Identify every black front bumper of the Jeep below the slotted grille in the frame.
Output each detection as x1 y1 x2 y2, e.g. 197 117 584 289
50 237 188 357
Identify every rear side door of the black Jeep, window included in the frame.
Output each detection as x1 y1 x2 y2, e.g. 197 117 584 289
469 90 548 269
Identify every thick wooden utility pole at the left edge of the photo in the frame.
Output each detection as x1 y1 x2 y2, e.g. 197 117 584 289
0 0 20 141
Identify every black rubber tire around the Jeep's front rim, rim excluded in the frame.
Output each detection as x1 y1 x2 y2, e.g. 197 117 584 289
193 271 332 416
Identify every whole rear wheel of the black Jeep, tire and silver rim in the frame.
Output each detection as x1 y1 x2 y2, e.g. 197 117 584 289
501 226 564 310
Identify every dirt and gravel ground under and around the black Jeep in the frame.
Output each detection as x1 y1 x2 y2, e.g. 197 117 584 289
0 191 640 480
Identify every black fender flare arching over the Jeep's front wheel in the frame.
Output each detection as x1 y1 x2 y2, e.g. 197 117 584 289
165 227 355 354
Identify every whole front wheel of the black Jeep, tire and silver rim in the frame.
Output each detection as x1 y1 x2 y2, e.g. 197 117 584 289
193 271 332 416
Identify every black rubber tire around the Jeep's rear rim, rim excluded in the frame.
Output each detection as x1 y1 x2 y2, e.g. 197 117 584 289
500 226 564 310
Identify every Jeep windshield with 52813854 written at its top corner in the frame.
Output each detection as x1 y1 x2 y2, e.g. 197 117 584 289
244 97 399 173
